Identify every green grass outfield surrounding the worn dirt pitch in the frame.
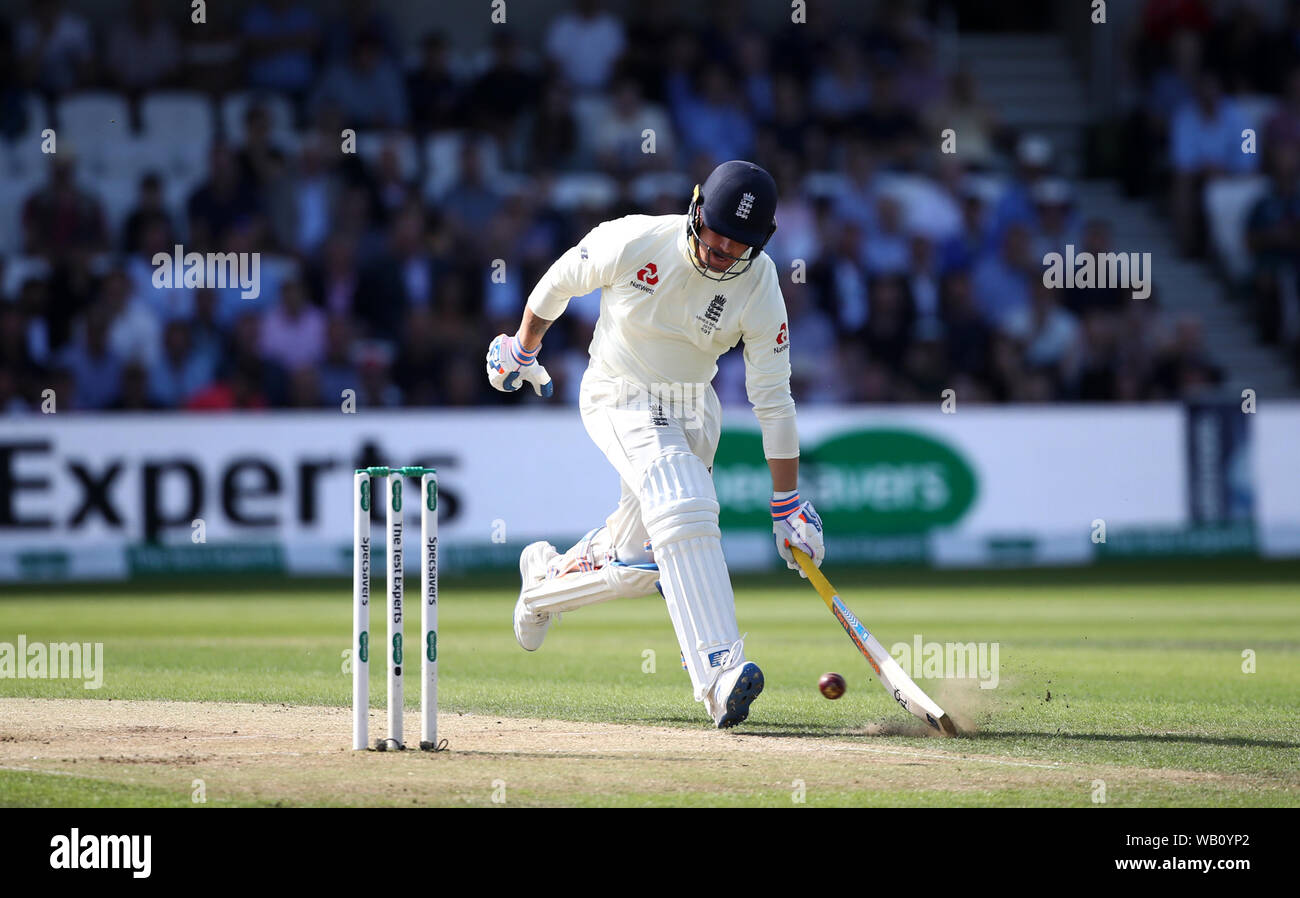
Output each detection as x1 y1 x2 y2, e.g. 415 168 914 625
0 560 1300 806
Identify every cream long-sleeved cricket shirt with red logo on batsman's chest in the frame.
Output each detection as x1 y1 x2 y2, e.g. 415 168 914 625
528 214 800 459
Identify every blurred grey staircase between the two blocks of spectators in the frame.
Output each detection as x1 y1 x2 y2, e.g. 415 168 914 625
957 34 1300 398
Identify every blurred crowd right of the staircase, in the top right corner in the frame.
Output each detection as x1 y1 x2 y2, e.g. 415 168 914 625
1123 0 1300 377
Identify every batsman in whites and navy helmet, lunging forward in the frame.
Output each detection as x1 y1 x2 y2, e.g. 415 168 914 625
488 161 826 728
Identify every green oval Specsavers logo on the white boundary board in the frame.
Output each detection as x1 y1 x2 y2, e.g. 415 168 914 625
714 428 976 537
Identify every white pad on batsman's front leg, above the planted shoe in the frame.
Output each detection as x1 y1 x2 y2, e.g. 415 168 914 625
641 450 745 702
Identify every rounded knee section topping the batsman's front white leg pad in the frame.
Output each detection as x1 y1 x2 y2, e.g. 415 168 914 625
641 450 722 550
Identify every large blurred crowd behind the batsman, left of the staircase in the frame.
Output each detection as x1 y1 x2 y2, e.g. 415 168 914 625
0 0 1232 412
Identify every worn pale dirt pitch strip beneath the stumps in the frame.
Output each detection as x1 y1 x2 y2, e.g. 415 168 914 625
0 698 1260 806
